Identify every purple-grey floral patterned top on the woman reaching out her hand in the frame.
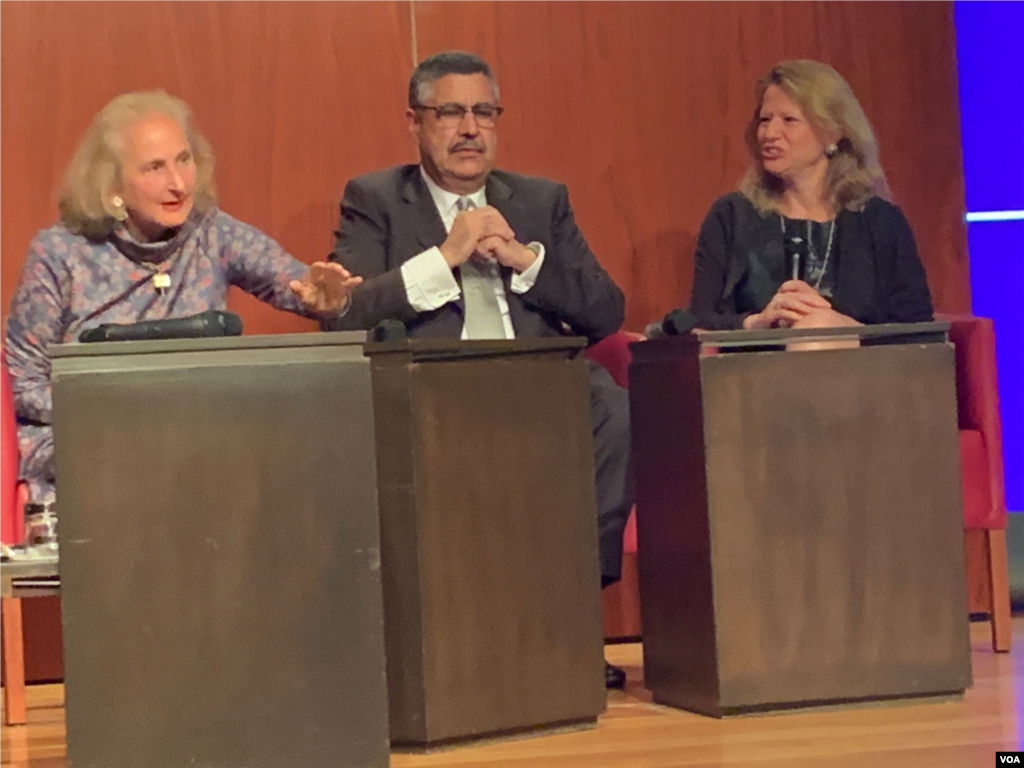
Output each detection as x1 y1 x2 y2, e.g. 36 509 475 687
4 209 312 501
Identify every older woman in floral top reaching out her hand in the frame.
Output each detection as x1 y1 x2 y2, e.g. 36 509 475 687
4 91 359 501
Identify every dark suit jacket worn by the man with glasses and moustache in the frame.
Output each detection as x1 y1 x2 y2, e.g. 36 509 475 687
330 165 625 342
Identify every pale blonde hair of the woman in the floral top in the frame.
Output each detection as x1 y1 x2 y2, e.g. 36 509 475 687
57 90 217 239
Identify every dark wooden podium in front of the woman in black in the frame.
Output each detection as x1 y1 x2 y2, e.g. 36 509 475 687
630 324 971 717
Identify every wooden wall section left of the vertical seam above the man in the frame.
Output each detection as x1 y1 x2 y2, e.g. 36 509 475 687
0 0 413 333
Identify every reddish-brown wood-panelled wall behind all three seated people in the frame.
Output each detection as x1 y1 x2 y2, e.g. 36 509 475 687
0 0 970 332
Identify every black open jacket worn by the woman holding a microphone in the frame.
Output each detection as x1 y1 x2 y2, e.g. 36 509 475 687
690 193 932 330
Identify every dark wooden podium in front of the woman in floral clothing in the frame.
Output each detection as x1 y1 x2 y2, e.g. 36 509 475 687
53 333 388 768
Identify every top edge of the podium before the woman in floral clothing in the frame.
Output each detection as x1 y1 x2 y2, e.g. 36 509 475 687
49 331 367 357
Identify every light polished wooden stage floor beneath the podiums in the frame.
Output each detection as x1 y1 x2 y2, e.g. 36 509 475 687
0 616 1024 768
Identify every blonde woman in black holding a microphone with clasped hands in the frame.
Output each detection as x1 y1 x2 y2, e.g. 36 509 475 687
690 60 932 330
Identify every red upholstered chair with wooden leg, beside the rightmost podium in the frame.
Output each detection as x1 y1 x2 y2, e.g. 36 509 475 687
936 315 1011 651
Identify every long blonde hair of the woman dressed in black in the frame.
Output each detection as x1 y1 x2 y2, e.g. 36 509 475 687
739 59 889 213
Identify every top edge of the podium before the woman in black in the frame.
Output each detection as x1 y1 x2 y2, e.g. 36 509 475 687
630 321 949 350
